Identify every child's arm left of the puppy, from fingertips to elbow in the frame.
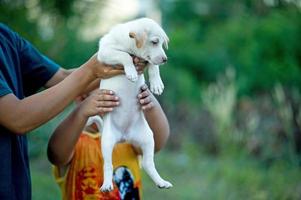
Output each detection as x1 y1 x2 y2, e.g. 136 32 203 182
47 90 119 167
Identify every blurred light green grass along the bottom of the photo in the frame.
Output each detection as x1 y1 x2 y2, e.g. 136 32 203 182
31 150 301 200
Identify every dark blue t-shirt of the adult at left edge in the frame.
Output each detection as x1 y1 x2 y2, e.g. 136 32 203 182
0 23 59 200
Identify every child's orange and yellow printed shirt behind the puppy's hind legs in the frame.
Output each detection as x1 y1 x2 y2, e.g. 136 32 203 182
55 133 142 200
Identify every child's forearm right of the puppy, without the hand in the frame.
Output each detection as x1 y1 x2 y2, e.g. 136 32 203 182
144 97 170 152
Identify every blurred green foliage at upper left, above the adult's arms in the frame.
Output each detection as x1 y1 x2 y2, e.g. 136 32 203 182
0 0 103 68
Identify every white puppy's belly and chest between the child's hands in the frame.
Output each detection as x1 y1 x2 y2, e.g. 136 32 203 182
100 75 145 135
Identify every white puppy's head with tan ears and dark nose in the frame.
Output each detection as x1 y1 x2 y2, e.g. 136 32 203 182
129 18 169 65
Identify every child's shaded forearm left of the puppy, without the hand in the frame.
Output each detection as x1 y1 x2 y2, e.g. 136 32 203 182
47 109 87 166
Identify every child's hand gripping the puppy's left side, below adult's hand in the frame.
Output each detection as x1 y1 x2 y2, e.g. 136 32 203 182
78 89 119 117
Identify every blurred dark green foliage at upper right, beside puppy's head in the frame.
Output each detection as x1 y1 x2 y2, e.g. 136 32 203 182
162 1 301 97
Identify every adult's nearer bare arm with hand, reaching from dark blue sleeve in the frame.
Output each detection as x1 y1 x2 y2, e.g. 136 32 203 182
0 55 124 134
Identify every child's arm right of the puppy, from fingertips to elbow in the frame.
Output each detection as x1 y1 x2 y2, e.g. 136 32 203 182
138 85 170 152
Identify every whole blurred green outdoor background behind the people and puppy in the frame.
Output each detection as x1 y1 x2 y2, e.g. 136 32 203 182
0 0 301 200
